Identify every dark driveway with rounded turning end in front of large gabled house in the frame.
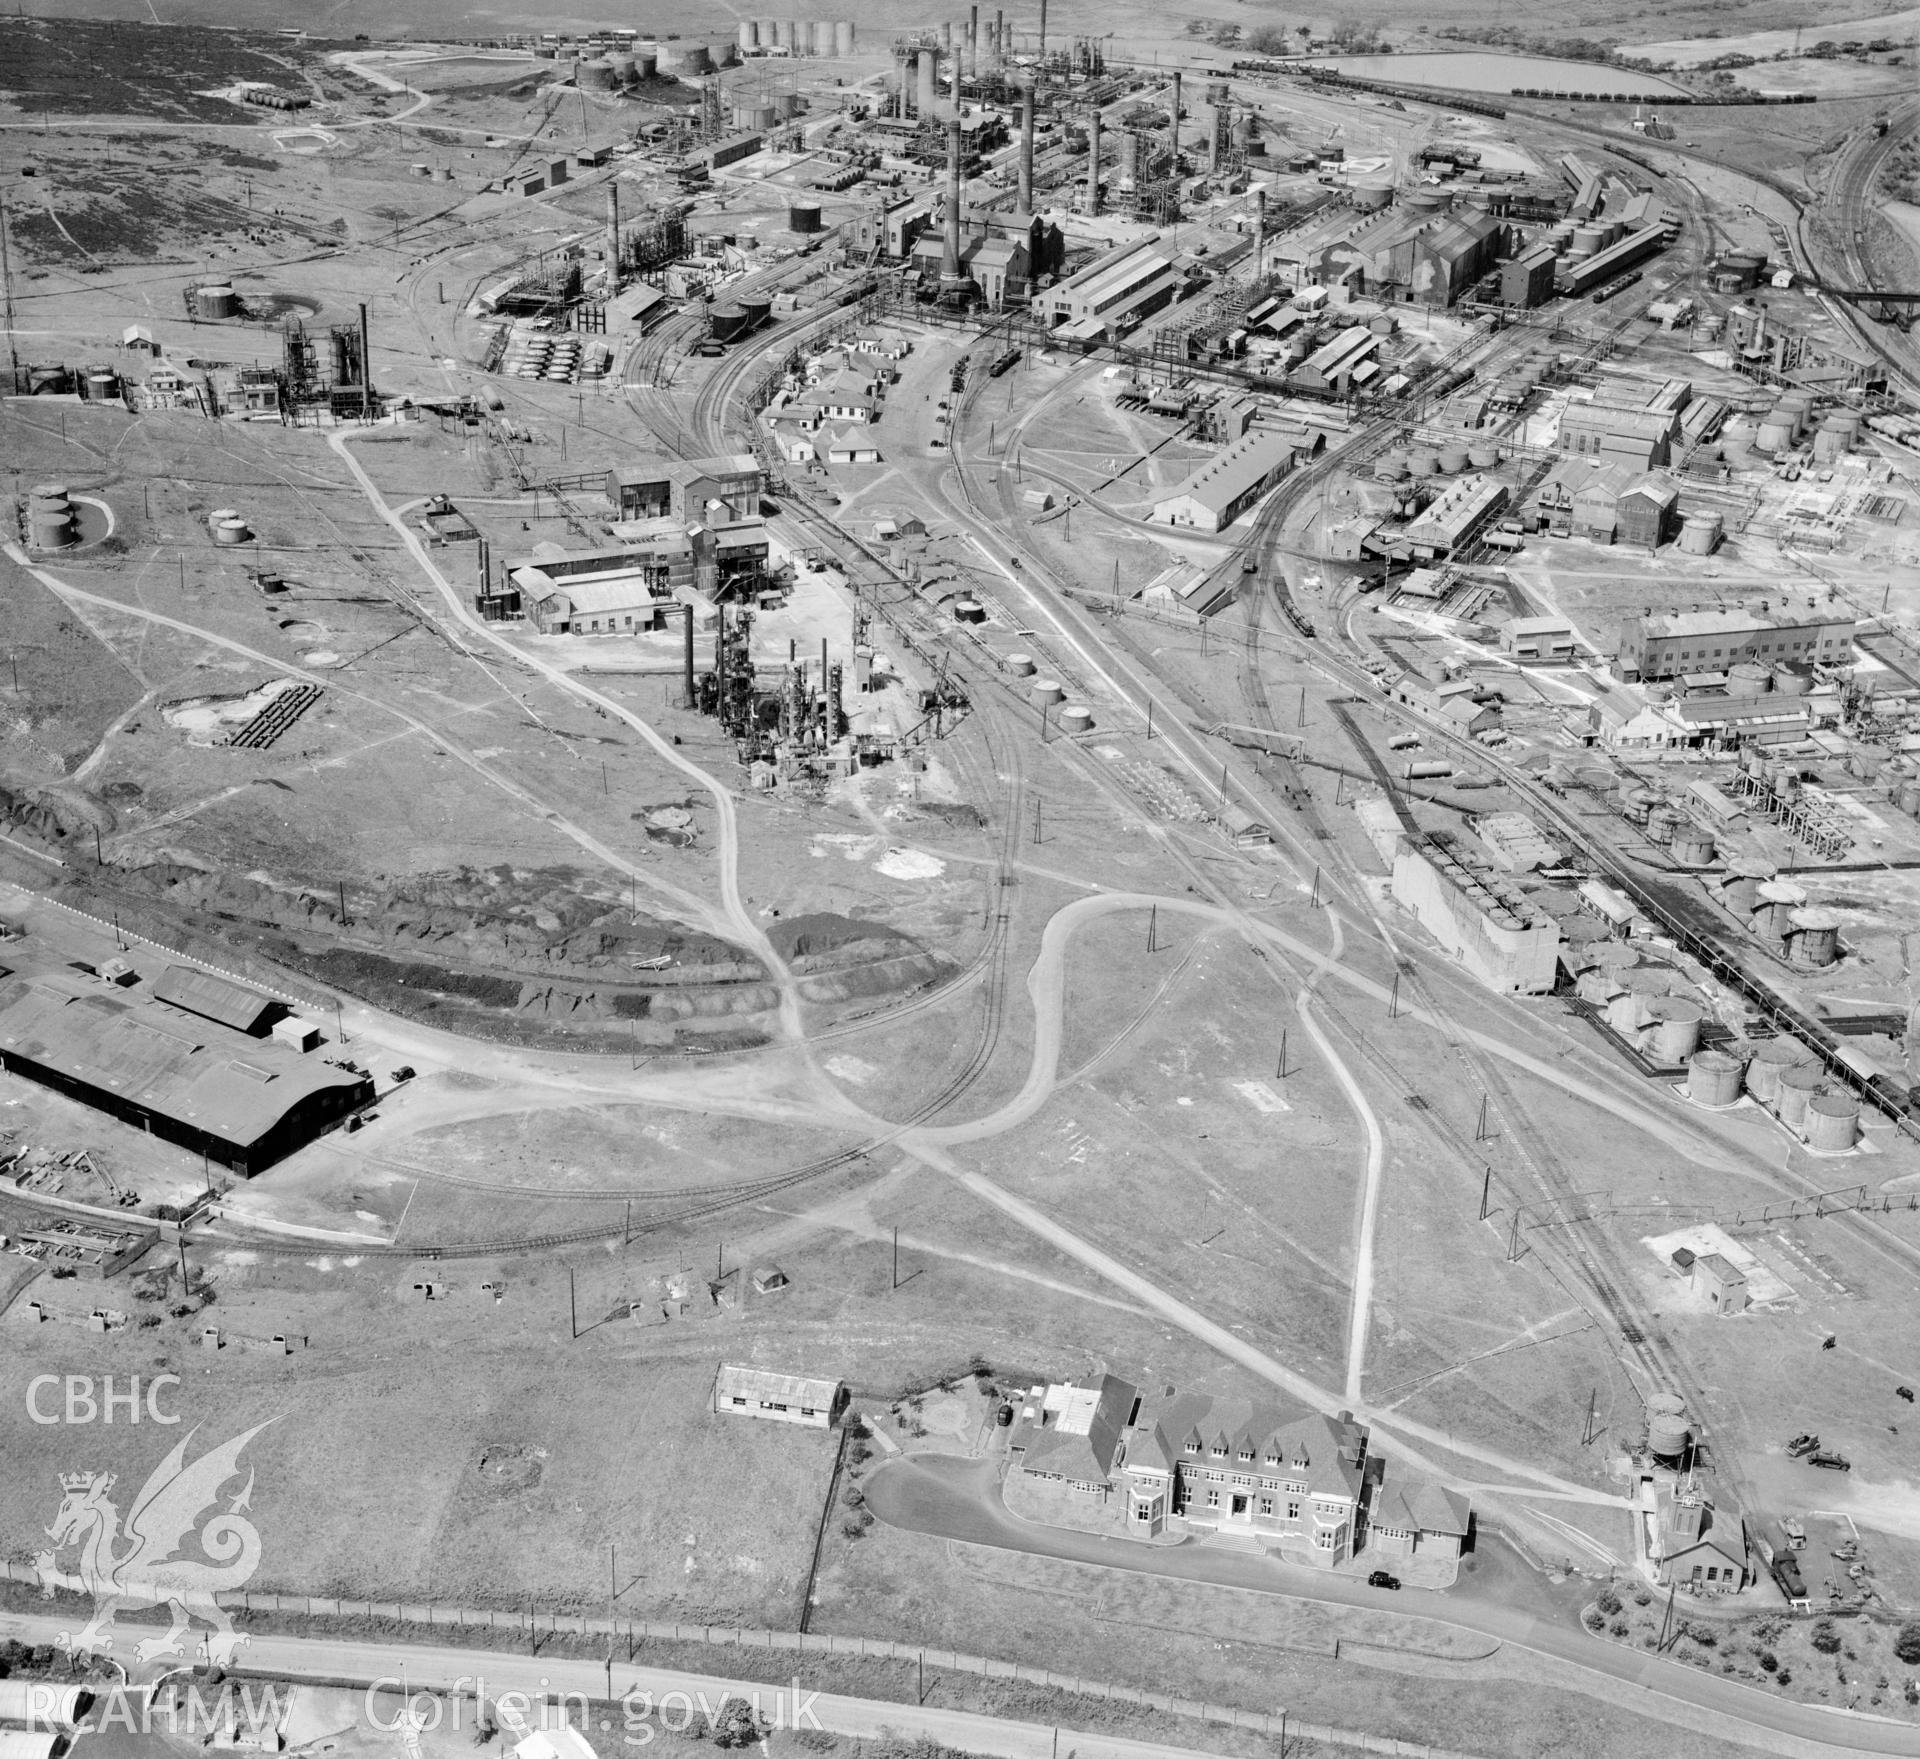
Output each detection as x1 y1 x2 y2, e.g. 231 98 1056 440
866 1456 1920 1755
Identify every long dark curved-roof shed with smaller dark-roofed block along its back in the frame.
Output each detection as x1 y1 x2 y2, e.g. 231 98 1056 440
0 966 374 1177
